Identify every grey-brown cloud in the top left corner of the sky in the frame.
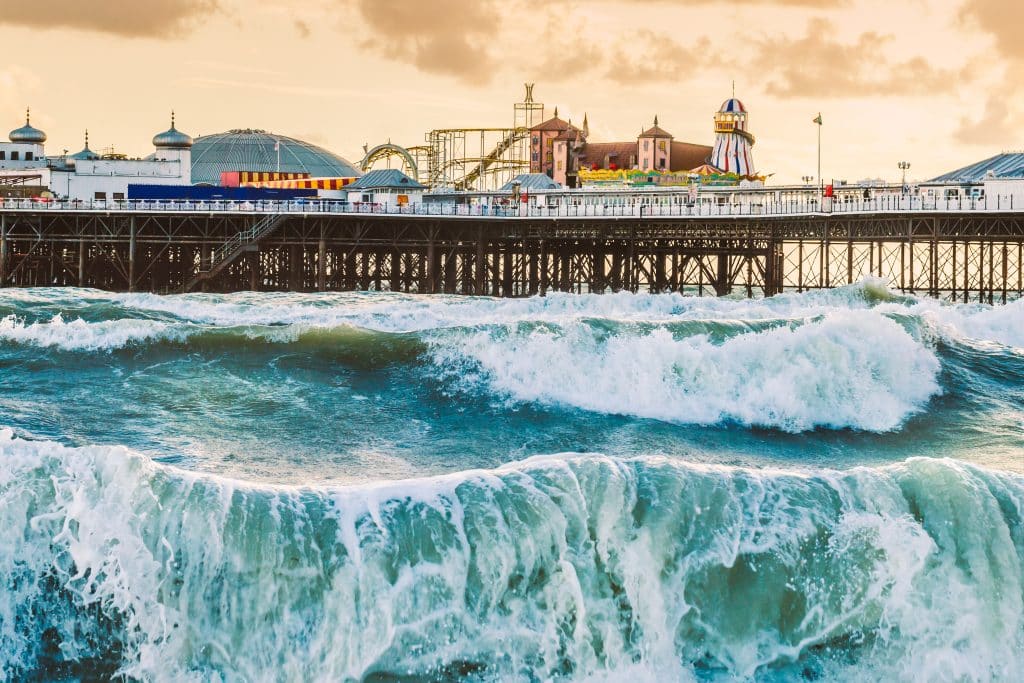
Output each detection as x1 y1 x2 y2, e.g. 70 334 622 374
0 0 219 38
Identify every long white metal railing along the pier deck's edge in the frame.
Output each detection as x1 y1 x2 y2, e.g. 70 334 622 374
0 195 1024 218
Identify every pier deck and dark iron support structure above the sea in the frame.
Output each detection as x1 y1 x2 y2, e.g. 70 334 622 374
0 201 1024 303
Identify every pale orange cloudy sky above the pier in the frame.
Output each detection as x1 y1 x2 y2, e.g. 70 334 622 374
0 0 1024 183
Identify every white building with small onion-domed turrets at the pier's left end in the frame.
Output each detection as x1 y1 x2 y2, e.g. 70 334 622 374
0 114 193 201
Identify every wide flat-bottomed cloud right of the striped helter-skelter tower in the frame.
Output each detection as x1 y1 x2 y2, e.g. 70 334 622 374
755 18 968 97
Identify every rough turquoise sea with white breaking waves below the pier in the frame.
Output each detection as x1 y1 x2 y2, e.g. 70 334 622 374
0 280 1024 683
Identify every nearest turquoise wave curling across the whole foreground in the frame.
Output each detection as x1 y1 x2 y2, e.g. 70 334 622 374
0 431 1024 681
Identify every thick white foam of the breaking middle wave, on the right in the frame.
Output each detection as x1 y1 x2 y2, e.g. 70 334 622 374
432 311 939 431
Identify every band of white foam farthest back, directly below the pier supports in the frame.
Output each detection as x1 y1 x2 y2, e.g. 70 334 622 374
6 280 1024 360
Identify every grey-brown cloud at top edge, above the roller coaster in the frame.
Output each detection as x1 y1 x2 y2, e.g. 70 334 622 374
345 0 505 85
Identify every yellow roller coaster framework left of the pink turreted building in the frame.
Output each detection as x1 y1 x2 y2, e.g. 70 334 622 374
359 83 544 190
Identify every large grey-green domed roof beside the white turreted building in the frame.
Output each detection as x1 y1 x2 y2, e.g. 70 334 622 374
191 128 361 184
